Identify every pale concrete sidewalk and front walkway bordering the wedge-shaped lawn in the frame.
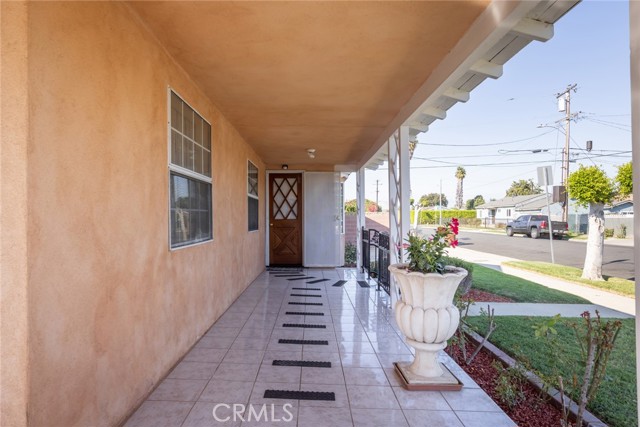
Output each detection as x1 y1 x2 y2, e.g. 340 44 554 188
449 247 636 317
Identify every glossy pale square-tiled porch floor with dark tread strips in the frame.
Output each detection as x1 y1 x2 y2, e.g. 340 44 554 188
125 268 515 427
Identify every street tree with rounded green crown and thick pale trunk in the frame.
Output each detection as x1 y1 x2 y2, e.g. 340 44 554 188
567 166 615 280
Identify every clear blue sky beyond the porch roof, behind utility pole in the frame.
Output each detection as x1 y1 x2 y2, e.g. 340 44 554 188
346 1 631 207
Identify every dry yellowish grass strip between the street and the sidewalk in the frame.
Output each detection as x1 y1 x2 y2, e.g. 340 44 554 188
503 261 635 297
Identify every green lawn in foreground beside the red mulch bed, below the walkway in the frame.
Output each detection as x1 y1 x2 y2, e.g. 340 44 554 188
468 318 638 427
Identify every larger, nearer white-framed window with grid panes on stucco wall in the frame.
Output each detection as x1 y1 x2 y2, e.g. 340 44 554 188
169 90 213 249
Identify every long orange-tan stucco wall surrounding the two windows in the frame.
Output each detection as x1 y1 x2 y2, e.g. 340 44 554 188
23 2 265 427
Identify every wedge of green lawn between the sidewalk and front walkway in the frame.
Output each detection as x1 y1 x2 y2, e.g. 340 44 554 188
472 264 591 304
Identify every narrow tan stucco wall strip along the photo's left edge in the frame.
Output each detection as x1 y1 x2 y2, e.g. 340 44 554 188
0 2 29 426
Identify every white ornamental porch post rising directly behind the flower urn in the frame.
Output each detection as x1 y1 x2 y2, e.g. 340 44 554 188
389 126 411 264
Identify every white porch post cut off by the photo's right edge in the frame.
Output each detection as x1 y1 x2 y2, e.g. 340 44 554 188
629 1 640 422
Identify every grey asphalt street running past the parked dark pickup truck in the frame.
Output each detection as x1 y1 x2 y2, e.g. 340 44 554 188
448 230 635 280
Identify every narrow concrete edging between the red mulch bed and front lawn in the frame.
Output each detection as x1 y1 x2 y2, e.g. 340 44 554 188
465 330 608 427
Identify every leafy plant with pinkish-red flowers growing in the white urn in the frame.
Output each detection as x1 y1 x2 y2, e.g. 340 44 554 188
403 218 458 274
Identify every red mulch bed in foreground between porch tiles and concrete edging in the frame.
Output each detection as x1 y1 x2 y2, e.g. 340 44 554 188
447 342 562 427
